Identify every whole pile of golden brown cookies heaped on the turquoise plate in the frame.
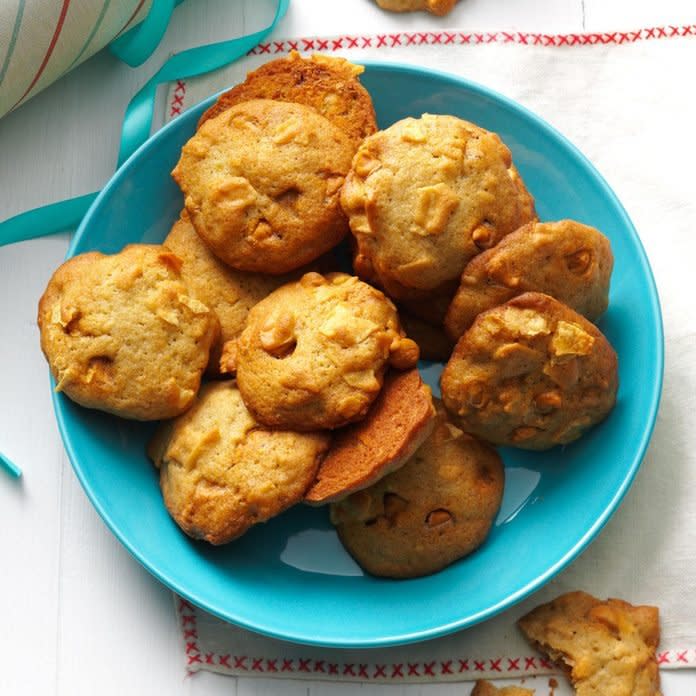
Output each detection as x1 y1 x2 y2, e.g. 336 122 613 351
39 53 617 578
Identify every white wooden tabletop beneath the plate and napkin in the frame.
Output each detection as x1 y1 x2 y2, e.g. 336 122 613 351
0 0 696 696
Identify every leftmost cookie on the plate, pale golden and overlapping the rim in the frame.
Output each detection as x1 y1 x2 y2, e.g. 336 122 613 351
38 244 218 420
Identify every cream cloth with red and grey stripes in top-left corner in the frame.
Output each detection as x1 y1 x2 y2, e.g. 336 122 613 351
0 0 152 116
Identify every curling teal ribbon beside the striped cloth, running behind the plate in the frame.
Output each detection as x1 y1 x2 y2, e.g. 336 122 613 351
0 0 290 246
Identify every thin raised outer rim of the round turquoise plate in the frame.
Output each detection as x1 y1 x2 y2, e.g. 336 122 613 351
50 60 664 648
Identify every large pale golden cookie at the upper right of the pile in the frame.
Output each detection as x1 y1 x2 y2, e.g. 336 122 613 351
341 114 536 300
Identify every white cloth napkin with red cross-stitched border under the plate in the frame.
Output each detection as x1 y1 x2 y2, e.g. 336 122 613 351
166 25 696 682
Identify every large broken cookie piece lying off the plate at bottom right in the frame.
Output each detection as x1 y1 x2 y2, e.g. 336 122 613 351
518 592 661 696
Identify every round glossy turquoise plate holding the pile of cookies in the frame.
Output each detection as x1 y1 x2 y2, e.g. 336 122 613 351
54 63 663 647
